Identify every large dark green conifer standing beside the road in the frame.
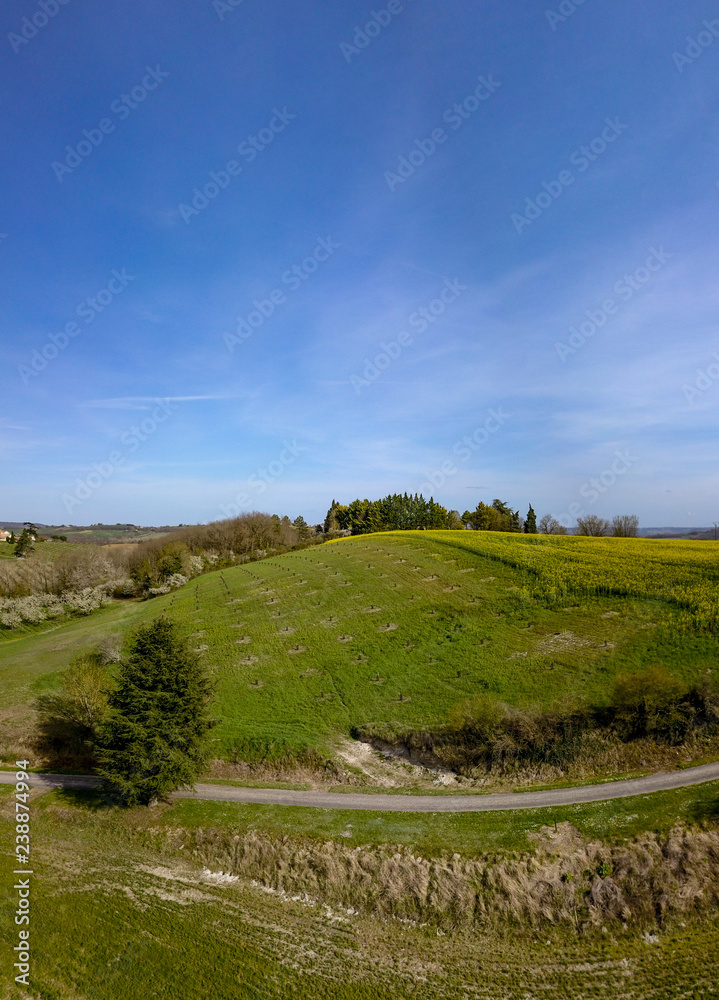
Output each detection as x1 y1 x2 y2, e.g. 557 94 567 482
96 618 214 805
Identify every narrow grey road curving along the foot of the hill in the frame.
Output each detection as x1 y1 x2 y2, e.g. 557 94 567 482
0 761 719 813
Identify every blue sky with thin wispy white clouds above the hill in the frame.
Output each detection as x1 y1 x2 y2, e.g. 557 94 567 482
0 0 719 525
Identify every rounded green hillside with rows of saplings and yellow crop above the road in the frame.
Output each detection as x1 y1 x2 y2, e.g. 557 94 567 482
0 531 719 758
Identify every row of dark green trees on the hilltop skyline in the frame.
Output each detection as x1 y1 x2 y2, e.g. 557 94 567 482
323 493 639 538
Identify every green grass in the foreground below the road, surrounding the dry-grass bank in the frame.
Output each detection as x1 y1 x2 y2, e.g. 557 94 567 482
0 786 719 1000
